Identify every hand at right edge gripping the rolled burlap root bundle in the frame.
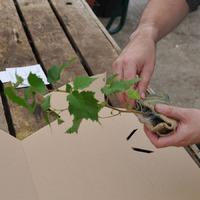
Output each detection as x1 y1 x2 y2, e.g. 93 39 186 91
144 105 200 148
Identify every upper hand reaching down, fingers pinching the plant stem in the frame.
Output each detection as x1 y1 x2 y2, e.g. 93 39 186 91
113 27 156 105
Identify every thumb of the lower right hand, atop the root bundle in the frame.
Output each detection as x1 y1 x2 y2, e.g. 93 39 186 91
155 104 185 120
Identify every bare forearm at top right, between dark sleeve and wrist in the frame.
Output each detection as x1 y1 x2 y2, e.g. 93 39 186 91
132 0 189 42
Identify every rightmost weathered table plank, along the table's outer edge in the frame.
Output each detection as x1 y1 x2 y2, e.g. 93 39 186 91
49 0 118 74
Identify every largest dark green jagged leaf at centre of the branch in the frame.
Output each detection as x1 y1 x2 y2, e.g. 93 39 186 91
67 91 101 121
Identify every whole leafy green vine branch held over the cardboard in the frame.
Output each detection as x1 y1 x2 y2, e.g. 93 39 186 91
5 59 140 134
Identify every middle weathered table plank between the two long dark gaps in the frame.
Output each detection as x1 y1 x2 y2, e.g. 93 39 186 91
17 0 86 87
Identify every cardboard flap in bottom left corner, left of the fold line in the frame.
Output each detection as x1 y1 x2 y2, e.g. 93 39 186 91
0 131 38 200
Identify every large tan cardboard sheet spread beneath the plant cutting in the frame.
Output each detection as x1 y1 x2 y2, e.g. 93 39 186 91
0 74 200 200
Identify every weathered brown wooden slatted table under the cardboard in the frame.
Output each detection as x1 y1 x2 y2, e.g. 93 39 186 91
0 0 119 139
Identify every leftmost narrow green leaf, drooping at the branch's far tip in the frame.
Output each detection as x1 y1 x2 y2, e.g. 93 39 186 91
4 87 30 109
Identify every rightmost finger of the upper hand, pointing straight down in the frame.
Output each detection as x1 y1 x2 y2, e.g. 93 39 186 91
138 66 153 99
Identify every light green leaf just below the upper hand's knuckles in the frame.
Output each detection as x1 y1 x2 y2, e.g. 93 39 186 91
101 78 140 96
